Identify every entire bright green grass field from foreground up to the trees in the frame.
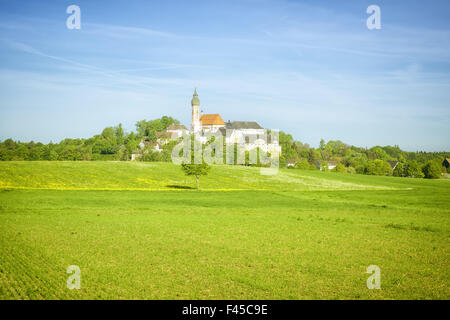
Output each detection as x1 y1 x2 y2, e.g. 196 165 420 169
0 162 450 299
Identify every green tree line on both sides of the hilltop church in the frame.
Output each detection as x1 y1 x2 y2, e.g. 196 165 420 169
0 116 450 178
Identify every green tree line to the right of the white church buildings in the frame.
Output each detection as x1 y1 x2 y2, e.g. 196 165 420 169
279 132 450 178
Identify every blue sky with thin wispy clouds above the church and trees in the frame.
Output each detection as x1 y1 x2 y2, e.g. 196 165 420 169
0 0 450 151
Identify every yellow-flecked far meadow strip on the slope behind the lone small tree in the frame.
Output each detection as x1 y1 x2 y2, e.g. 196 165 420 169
0 161 440 191
